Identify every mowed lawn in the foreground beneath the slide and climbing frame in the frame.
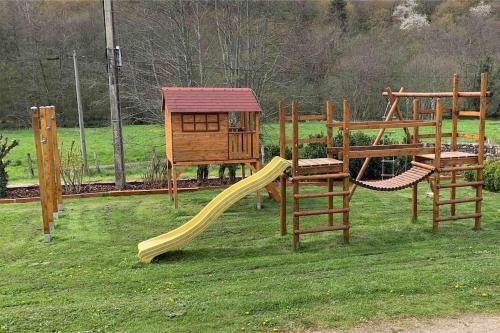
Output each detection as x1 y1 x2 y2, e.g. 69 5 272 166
0 184 500 332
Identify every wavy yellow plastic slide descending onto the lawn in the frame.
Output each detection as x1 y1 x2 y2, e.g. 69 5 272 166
137 157 290 263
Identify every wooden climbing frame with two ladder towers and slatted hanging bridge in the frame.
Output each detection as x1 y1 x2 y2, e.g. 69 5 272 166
279 73 489 248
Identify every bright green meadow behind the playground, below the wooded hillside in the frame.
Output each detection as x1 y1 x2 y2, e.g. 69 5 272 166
0 120 500 184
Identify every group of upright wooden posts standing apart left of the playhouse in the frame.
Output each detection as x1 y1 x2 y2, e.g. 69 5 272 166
31 106 63 242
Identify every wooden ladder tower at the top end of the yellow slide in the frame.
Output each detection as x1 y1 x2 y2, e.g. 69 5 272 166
278 100 350 249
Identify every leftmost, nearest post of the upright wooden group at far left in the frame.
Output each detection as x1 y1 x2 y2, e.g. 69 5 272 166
31 107 52 242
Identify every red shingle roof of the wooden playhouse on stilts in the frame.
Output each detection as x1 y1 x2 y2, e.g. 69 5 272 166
162 87 262 113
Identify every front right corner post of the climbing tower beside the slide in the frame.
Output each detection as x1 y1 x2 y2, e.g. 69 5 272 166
342 100 350 243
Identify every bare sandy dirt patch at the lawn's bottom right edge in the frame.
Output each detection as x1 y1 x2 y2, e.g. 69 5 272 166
304 314 500 333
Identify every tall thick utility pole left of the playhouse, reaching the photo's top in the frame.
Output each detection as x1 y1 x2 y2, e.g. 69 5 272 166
103 0 125 189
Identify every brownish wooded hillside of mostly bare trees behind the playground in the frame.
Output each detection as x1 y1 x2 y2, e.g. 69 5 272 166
0 0 500 129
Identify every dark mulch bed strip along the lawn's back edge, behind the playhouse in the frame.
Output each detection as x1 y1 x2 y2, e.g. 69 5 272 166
3 178 240 199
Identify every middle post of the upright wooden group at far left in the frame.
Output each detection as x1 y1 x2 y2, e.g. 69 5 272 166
40 107 57 230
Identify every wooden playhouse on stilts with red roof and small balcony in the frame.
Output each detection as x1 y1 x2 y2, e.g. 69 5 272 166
162 87 279 208
